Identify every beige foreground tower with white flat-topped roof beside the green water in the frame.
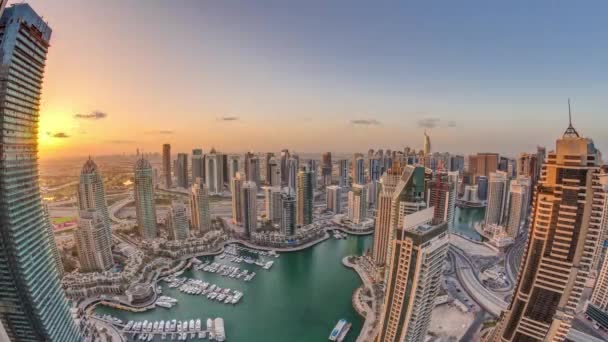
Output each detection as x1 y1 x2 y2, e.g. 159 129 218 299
376 208 449 342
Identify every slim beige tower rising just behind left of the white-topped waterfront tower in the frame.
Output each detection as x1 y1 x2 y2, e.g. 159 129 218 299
372 166 401 267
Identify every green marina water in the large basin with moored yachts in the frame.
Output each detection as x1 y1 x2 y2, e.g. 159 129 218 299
96 236 372 342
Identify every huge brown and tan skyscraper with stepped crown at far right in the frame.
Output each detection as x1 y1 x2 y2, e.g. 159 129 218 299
489 124 603 342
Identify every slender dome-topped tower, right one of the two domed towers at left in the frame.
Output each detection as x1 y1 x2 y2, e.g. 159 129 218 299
133 155 157 239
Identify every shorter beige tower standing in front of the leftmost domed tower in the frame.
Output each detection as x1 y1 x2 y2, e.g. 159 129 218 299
74 209 114 272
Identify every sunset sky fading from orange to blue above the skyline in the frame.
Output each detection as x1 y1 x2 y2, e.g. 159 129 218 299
15 0 608 158
